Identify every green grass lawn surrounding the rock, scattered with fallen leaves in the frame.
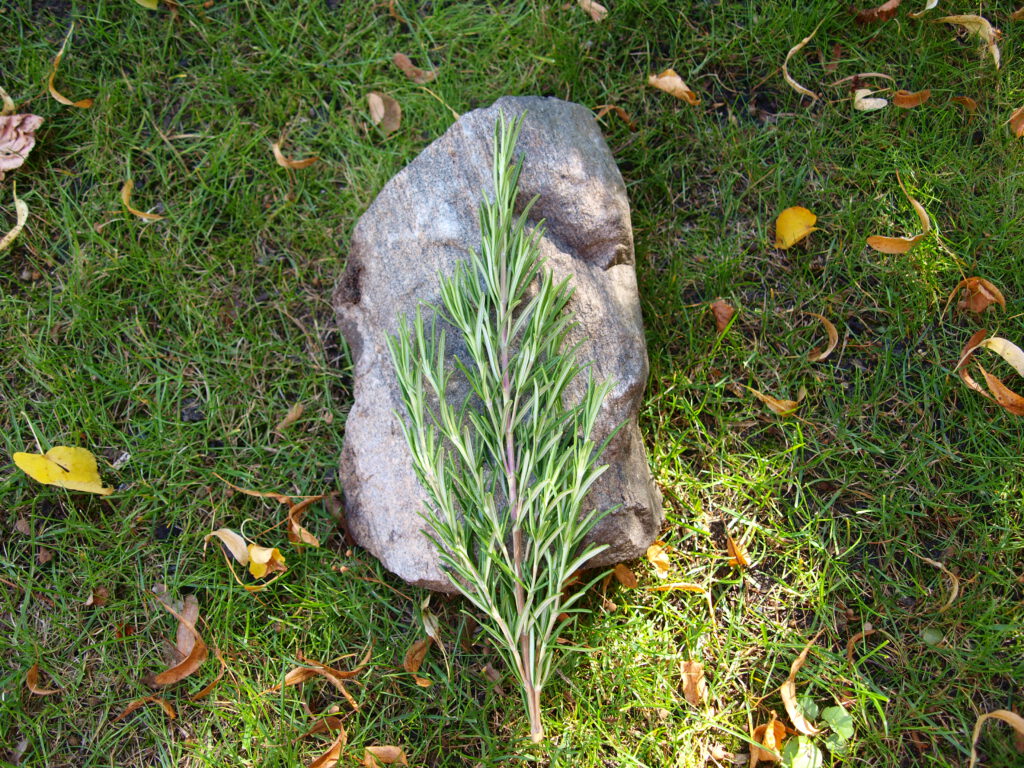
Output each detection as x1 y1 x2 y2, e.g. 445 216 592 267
0 0 1024 767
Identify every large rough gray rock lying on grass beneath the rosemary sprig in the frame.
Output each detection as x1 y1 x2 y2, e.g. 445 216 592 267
334 96 664 592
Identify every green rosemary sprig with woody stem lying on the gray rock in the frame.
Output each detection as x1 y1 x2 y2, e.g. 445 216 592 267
389 116 608 742
